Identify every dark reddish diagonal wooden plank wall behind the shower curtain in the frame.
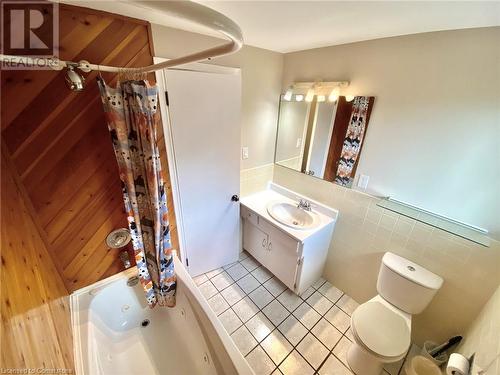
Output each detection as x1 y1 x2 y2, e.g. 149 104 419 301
1 4 178 292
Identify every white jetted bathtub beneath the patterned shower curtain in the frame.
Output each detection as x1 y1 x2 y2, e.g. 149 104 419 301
70 257 254 375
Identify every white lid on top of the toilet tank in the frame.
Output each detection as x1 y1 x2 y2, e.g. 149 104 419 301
382 252 443 290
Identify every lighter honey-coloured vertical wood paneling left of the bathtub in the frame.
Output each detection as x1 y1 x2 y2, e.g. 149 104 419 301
0 154 73 369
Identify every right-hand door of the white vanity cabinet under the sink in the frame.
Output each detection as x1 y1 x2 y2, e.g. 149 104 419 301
266 231 300 290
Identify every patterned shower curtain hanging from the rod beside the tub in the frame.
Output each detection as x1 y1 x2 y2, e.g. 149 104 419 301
98 78 176 307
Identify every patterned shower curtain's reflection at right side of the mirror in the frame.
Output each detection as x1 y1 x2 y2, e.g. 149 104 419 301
335 96 370 186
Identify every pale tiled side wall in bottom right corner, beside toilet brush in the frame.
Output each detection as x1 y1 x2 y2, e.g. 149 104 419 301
458 286 500 375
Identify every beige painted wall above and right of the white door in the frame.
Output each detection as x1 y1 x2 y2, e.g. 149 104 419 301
151 24 283 169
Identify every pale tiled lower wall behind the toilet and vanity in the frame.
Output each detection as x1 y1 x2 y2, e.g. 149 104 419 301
273 166 500 345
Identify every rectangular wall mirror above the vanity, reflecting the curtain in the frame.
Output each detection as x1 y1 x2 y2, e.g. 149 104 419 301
275 96 375 187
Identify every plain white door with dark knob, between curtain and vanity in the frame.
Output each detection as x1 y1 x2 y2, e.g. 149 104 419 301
157 64 241 276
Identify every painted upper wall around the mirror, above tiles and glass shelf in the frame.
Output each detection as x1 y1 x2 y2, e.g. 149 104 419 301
283 27 500 238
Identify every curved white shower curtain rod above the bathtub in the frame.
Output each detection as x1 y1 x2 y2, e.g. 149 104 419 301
0 1 243 73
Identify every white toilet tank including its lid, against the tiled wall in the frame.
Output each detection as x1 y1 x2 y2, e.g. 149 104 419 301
377 253 443 314
